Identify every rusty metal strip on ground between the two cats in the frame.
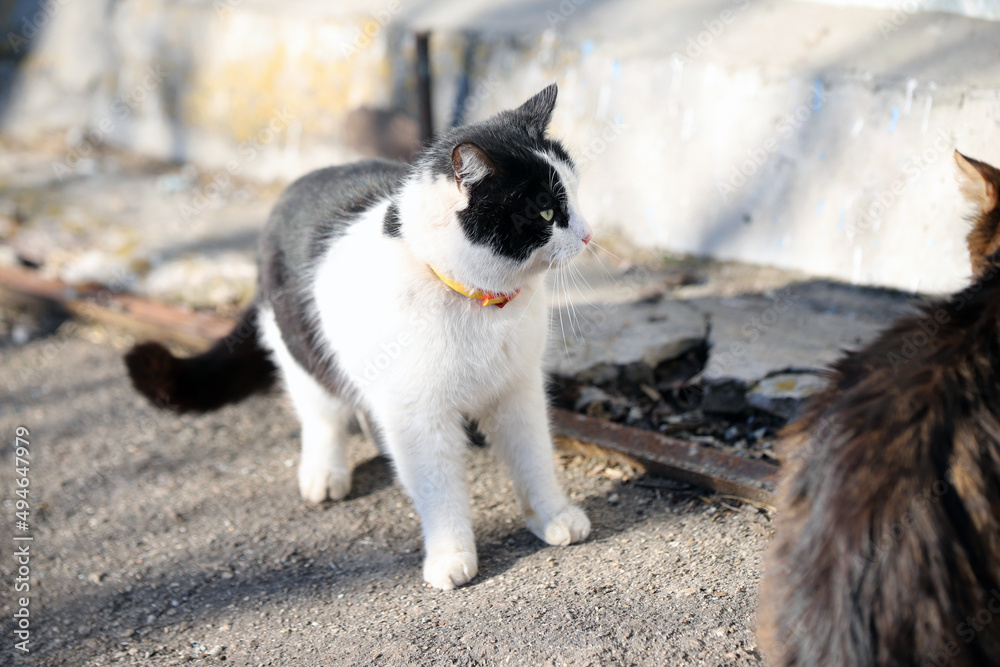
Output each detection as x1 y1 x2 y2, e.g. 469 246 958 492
551 409 778 505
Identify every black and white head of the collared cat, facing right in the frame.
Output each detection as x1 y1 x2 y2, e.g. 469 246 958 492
397 84 591 292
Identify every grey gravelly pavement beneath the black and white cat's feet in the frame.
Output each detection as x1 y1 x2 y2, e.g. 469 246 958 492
0 330 770 666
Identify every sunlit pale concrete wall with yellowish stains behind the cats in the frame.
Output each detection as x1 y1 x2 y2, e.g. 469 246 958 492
3 0 1000 291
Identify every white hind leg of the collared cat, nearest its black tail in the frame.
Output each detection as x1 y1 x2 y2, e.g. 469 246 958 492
258 309 354 503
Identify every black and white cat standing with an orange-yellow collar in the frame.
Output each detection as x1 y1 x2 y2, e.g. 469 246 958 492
126 85 591 589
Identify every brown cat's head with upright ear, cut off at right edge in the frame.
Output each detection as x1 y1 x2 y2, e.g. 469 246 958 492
955 151 1000 275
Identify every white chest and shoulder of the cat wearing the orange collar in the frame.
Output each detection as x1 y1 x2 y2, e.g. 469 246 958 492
314 214 548 413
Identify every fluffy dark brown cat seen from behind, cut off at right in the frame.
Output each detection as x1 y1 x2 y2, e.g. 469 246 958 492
758 152 1000 667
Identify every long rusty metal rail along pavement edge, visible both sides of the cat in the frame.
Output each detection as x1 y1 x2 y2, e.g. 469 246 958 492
0 267 778 505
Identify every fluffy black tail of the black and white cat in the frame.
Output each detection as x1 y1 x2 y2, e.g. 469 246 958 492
125 306 277 412
